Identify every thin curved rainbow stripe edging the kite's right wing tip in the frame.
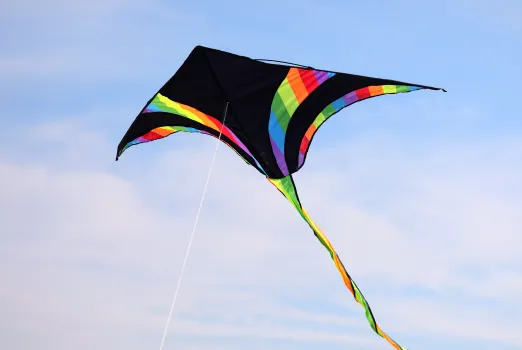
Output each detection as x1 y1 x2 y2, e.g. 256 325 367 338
297 85 422 168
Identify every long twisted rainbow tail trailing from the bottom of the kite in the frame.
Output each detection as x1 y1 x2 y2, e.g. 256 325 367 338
268 175 406 350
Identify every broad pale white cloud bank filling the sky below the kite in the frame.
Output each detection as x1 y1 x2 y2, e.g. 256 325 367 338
0 115 522 349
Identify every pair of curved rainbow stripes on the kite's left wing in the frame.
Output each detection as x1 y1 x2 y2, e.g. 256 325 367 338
121 93 266 175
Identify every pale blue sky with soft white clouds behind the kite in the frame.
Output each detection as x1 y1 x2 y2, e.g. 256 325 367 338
0 0 522 350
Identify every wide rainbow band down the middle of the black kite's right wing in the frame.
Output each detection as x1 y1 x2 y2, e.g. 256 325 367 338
268 67 335 176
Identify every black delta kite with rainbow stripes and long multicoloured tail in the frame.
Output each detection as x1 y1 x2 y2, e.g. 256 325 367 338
116 46 445 350
